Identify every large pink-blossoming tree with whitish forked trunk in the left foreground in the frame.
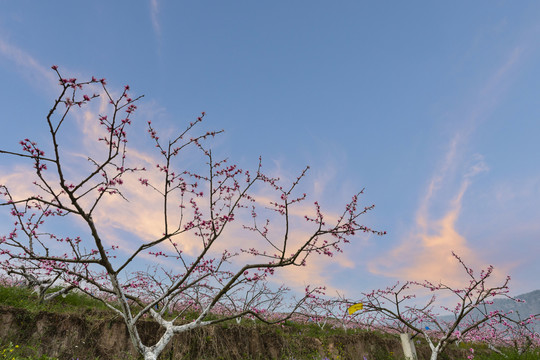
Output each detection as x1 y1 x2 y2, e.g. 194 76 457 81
0 66 383 359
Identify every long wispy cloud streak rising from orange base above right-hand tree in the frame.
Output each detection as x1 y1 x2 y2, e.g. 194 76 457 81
369 42 523 284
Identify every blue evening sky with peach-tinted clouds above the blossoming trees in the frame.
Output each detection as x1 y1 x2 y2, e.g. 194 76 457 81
0 0 540 304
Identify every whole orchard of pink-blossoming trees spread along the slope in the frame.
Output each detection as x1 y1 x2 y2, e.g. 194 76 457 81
0 66 540 360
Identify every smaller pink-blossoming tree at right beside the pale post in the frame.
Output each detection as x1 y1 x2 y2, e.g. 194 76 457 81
361 253 515 360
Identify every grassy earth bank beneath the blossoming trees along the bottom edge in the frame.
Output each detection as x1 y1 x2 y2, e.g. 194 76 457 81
0 287 540 360
